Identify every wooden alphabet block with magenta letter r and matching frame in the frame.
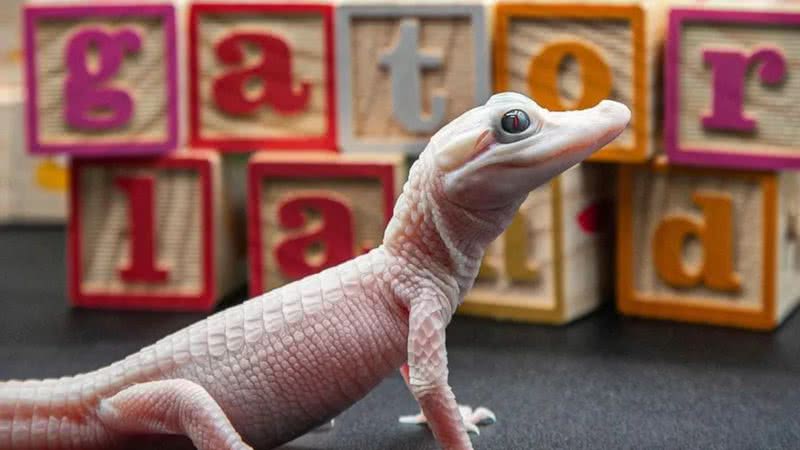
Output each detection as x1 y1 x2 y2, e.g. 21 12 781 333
664 2 800 169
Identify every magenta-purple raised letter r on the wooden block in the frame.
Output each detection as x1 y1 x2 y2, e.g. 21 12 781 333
703 48 786 131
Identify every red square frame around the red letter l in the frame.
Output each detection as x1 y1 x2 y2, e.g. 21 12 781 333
67 154 216 311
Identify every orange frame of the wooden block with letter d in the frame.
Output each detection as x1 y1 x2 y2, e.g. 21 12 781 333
617 160 797 330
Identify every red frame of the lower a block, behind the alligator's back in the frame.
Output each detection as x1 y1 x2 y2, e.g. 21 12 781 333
247 159 397 297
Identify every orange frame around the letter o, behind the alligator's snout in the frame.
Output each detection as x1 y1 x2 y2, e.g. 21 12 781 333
493 3 655 163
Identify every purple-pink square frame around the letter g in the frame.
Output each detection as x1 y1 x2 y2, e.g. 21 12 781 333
23 4 178 156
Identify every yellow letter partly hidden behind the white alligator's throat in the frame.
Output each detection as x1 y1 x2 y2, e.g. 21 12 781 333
478 213 539 282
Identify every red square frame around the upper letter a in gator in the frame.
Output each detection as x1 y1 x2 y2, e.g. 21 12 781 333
189 3 337 152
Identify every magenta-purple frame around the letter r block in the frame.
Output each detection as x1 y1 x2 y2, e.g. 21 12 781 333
664 9 800 169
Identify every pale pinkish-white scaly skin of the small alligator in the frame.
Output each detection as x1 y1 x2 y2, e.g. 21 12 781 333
0 94 630 450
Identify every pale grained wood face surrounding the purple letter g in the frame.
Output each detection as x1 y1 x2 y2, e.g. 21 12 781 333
34 17 169 144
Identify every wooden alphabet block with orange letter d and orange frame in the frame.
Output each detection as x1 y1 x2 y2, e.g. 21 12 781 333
617 161 800 329
